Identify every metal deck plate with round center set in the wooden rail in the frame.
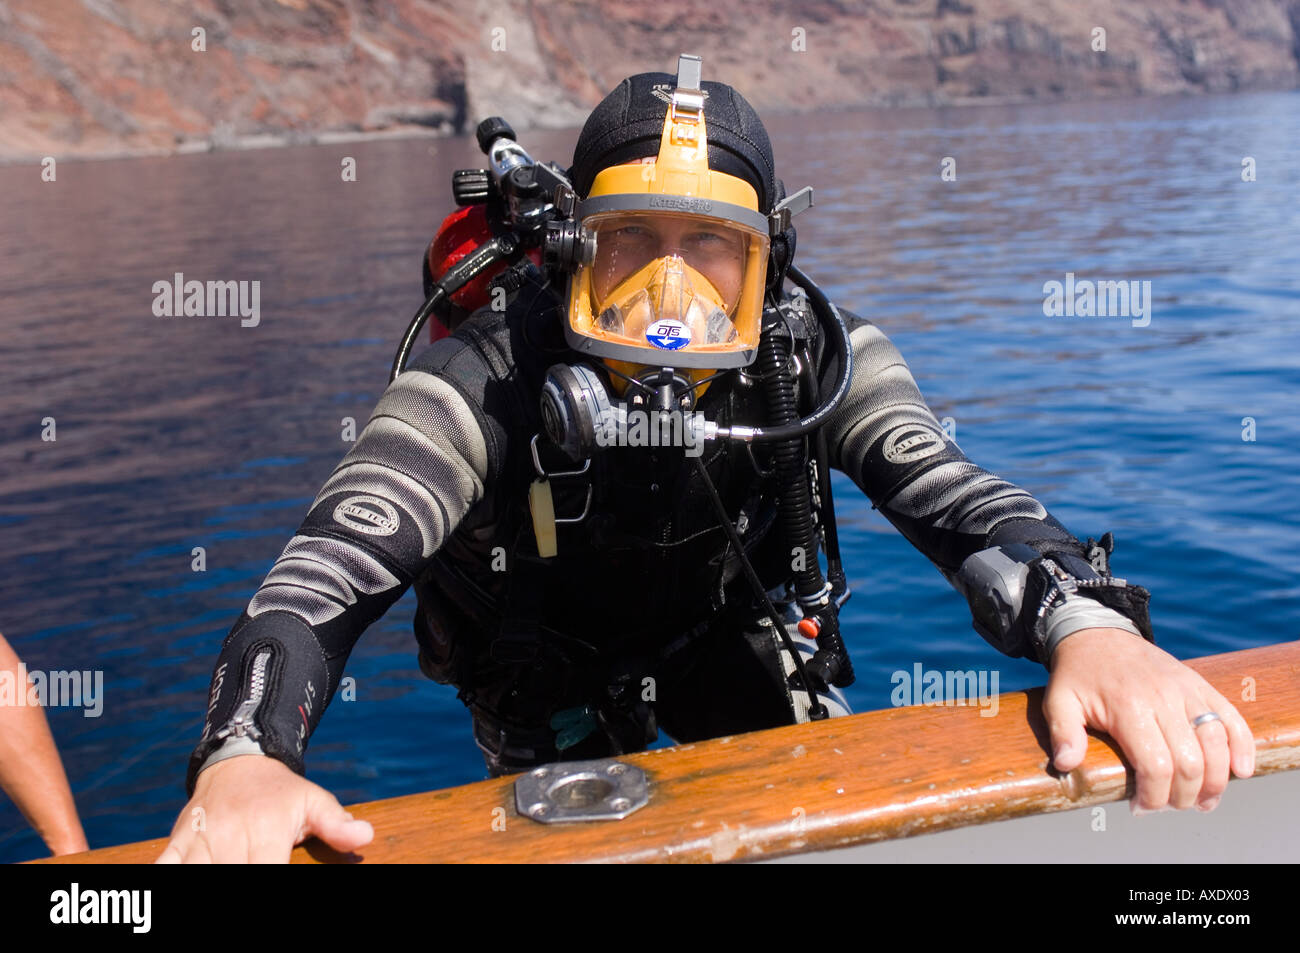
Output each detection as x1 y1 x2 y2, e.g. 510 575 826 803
515 758 650 824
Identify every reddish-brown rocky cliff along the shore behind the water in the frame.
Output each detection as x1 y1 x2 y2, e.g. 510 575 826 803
0 0 1300 160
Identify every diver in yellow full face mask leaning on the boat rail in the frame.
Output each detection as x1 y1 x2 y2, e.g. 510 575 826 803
160 56 1253 862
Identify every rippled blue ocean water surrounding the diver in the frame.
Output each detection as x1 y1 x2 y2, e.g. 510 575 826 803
0 94 1300 861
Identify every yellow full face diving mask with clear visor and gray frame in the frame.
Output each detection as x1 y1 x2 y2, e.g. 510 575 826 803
566 60 770 391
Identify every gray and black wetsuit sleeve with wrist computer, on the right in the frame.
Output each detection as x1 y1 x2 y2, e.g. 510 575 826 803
823 311 1152 664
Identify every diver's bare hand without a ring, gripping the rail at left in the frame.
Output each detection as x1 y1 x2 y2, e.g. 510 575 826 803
155 754 374 863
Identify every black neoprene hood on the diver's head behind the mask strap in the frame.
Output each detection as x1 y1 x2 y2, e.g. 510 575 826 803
569 73 777 213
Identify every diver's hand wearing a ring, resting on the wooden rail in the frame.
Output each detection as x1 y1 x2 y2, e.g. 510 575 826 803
1043 628 1255 814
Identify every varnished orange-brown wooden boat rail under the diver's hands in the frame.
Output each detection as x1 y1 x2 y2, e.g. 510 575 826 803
30 641 1300 863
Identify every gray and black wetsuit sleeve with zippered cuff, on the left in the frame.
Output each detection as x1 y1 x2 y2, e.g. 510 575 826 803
186 338 499 794
